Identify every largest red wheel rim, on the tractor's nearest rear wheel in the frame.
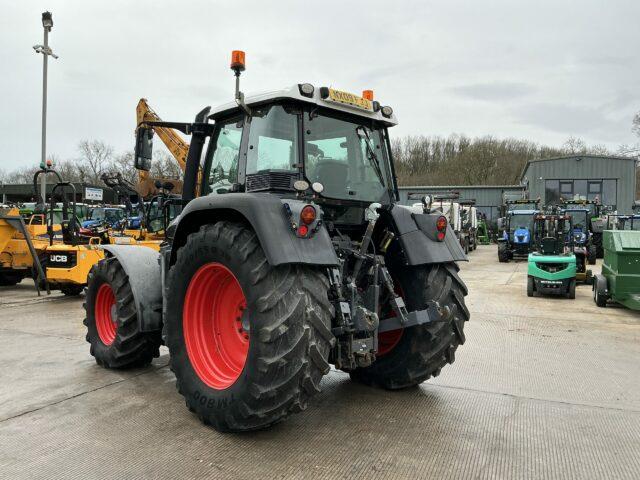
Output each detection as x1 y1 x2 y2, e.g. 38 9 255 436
182 262 249 390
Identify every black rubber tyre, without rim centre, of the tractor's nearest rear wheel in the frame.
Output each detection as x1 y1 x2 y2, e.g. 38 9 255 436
163 221 335 431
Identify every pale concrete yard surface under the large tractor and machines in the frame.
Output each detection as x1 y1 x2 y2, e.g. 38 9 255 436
0 246 640 480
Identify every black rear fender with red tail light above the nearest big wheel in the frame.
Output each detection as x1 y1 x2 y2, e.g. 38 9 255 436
171 193 339 266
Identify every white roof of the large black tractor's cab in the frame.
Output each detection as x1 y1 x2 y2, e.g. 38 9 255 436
209 84 398 127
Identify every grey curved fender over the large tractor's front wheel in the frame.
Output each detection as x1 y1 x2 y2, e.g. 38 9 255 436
103 245 162 332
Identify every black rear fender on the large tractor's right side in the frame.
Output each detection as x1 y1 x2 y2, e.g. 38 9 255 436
382 205 468 265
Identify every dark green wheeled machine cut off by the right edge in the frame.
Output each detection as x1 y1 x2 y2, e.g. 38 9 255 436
593 215 640 310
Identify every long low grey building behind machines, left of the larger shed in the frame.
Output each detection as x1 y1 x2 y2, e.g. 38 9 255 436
398 185 525 227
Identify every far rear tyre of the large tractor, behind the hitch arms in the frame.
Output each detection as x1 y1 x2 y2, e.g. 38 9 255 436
350 263 469 390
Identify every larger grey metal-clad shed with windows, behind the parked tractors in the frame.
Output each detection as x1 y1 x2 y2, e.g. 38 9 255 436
520 155 636 214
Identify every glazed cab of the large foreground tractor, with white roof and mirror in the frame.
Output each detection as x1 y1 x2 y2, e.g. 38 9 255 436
136 72 398 237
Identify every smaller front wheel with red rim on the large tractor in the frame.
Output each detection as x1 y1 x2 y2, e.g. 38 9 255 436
84 258 161 368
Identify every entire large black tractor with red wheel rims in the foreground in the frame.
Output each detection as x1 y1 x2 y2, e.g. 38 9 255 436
85 52 469 431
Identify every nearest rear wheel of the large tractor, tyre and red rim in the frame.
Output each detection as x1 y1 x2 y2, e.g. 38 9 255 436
163 221 335 431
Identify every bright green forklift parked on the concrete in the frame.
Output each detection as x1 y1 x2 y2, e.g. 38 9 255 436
527 212 576 299
